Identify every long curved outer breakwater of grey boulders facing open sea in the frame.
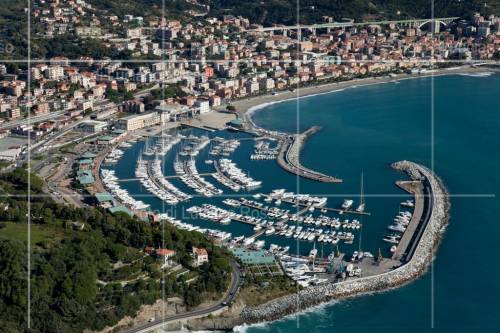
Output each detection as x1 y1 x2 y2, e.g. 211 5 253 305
240 161 449 324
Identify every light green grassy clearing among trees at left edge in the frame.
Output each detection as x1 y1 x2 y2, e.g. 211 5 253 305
0 222 60 245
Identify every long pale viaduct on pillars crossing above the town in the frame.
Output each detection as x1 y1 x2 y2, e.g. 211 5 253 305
246 17 459 32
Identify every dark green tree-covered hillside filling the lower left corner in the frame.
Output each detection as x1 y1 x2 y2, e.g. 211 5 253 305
0 168 230 332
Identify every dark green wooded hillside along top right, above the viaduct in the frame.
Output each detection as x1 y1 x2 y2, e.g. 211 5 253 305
205 0 500 25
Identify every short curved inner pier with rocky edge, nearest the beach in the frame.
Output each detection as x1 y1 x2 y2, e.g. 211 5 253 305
277 126 342 183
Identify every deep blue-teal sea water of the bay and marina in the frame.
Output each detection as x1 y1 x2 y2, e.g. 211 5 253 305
116 74 500 333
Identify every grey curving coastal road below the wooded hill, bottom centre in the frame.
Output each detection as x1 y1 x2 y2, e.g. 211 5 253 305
122 261 243 333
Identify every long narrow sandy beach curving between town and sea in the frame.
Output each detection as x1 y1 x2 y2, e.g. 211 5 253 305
231 66 499 119
